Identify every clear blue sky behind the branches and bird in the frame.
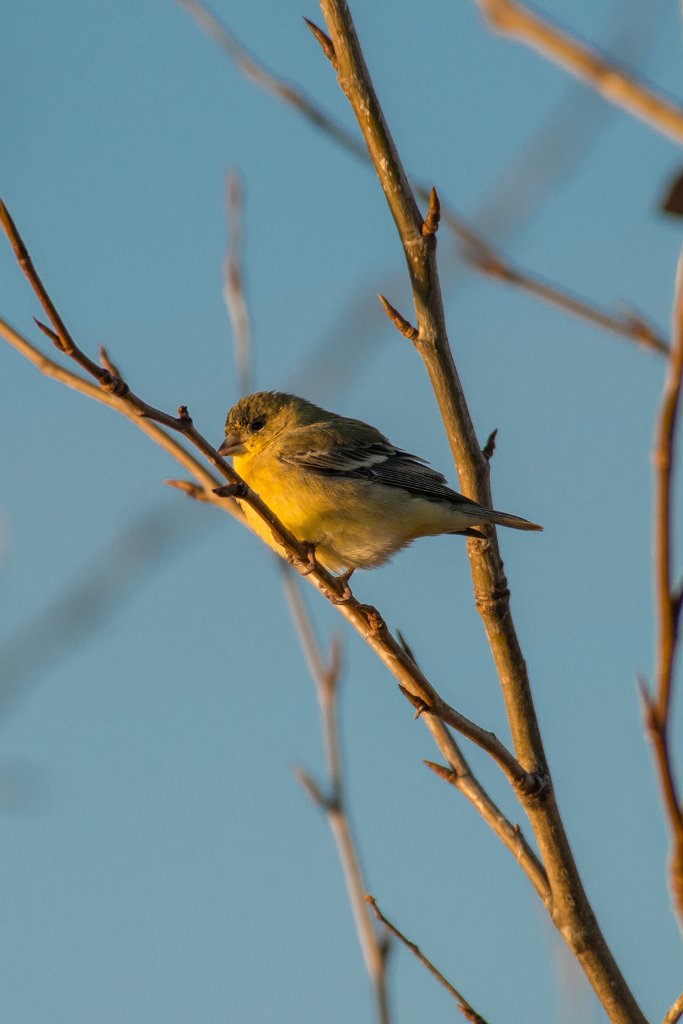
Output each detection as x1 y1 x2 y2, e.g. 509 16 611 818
0 0 683 1024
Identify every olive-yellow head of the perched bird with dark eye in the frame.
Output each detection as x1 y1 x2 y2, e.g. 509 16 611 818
218 391 325 456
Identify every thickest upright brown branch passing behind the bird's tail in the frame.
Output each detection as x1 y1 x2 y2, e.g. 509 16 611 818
315 8 645 1024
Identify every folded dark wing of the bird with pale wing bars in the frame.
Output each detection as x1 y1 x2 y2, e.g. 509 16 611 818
279 417 475 504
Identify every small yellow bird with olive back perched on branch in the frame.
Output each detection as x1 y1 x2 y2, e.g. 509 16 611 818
218 391 543 577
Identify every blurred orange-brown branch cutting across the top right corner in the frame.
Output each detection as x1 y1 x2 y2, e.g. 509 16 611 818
475 0 683 142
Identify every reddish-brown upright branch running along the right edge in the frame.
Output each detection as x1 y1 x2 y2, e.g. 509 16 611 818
642 252 683 926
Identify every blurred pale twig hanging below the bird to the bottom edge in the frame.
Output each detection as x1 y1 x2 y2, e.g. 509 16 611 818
283 567 390 1024
